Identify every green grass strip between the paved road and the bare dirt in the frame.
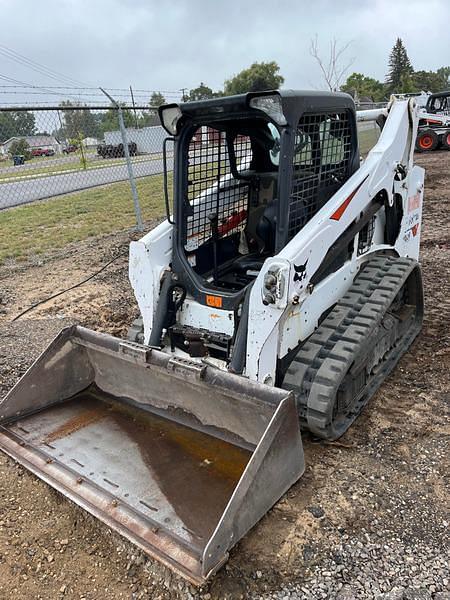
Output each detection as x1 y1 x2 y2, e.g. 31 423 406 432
0 175 170 264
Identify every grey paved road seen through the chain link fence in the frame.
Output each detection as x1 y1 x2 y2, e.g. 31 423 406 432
0 158 172 210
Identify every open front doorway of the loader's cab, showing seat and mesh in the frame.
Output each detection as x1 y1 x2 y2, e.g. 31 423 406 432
182 118 280 292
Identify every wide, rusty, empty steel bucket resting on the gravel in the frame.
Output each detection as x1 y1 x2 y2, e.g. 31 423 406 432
0 326 304 584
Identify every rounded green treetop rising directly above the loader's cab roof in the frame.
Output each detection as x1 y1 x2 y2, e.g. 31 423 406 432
224 60 284 96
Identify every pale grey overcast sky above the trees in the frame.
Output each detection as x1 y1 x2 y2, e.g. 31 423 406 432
0 0 450 100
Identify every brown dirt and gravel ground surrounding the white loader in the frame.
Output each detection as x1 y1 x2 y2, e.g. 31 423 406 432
0 152 450 600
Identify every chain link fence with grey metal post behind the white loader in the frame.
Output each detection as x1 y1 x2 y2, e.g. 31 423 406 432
0 103 379 266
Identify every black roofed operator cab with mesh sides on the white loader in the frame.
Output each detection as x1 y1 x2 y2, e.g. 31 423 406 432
160 91 359 310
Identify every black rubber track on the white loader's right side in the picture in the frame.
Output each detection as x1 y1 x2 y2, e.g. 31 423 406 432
282 255 423 440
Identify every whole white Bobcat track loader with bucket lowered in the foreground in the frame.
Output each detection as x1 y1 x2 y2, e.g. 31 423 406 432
0 91 424 583
